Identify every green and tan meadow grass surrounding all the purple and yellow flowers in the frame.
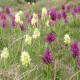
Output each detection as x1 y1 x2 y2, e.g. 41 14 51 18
0 0 80 80
